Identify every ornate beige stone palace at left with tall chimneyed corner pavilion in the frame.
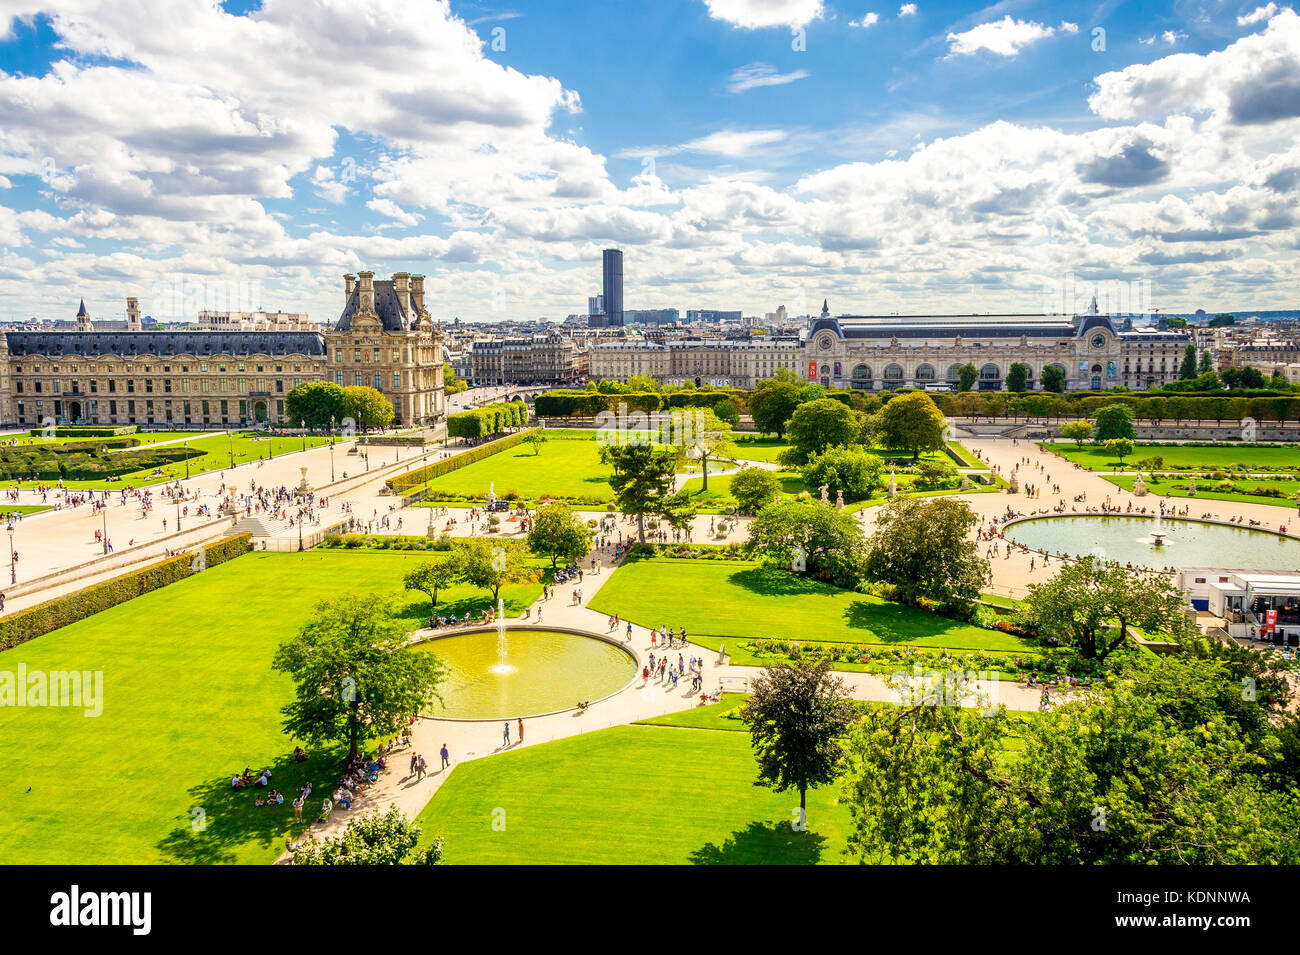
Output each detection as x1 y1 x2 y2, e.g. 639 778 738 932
0 272 446 429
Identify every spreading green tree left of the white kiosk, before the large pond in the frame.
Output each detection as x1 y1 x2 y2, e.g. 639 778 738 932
1021 555 1192 660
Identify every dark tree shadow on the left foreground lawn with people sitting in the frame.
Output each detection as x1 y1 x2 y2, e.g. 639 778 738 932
156 750 348 865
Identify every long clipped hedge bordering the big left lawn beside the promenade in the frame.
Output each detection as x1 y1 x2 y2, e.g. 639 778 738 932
0 534 252 650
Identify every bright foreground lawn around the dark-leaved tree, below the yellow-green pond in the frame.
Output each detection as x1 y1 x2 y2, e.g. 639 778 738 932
419 722 850 865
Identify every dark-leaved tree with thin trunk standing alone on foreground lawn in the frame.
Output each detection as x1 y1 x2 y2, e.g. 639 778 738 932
741 661 854 821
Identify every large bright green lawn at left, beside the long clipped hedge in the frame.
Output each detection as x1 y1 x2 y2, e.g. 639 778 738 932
0 551 540 864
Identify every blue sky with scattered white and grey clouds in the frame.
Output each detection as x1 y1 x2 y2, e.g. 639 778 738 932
0 0 1300 321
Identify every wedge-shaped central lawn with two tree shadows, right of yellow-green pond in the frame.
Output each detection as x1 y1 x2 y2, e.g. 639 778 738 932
590 557 1031 663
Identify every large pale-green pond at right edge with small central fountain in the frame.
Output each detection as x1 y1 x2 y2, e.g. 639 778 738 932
1002 515 1300 570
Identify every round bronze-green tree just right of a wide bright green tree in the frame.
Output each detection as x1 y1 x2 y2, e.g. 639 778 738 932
863 498 989 604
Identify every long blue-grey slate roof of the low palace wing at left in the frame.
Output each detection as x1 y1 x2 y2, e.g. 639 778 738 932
5 331 325 359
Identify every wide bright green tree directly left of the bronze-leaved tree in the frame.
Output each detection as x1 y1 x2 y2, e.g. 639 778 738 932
746 500 863 585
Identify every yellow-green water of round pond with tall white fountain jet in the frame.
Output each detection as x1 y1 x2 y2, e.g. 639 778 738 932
411 625 637 720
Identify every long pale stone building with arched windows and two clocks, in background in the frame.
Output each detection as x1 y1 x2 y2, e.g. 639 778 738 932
592 300 1192 391
